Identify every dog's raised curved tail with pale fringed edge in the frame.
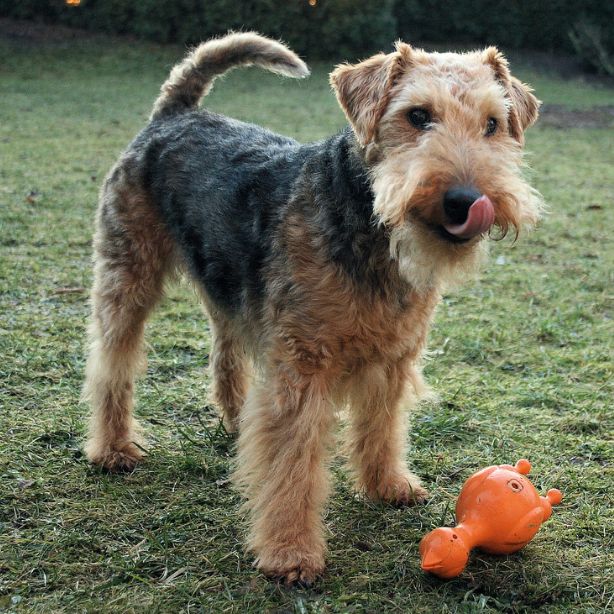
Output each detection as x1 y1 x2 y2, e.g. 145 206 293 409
151 32 309 119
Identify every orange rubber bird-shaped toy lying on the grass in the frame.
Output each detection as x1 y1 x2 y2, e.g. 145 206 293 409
420 459 563 579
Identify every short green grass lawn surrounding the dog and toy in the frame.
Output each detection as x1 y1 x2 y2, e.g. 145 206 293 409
0 32 614 613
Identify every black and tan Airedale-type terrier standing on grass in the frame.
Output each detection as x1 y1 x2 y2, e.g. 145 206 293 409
84 32 542 584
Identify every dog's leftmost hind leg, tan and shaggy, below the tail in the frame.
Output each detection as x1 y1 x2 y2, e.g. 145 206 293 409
83 169 171 470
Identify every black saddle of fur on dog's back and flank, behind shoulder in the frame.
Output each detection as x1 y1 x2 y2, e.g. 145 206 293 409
141 111 304 313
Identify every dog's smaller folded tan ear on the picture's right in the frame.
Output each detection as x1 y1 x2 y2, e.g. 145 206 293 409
483 47 541 143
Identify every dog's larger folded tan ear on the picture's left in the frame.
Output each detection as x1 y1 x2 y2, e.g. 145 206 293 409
330 41 412 147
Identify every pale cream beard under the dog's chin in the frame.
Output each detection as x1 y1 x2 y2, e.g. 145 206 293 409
390 223 488 293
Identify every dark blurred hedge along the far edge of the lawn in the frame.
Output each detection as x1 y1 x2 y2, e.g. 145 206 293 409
0 0 614 76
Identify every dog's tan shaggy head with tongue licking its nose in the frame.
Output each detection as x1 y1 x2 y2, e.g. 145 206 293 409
331 43 542 294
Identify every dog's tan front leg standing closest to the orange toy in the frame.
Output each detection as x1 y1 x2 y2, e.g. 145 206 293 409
348 360 428 505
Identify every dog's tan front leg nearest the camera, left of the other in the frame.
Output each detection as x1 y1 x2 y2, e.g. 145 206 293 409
235 367 334 584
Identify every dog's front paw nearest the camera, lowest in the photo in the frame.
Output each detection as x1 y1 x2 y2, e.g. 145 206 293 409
256 548 326 586
